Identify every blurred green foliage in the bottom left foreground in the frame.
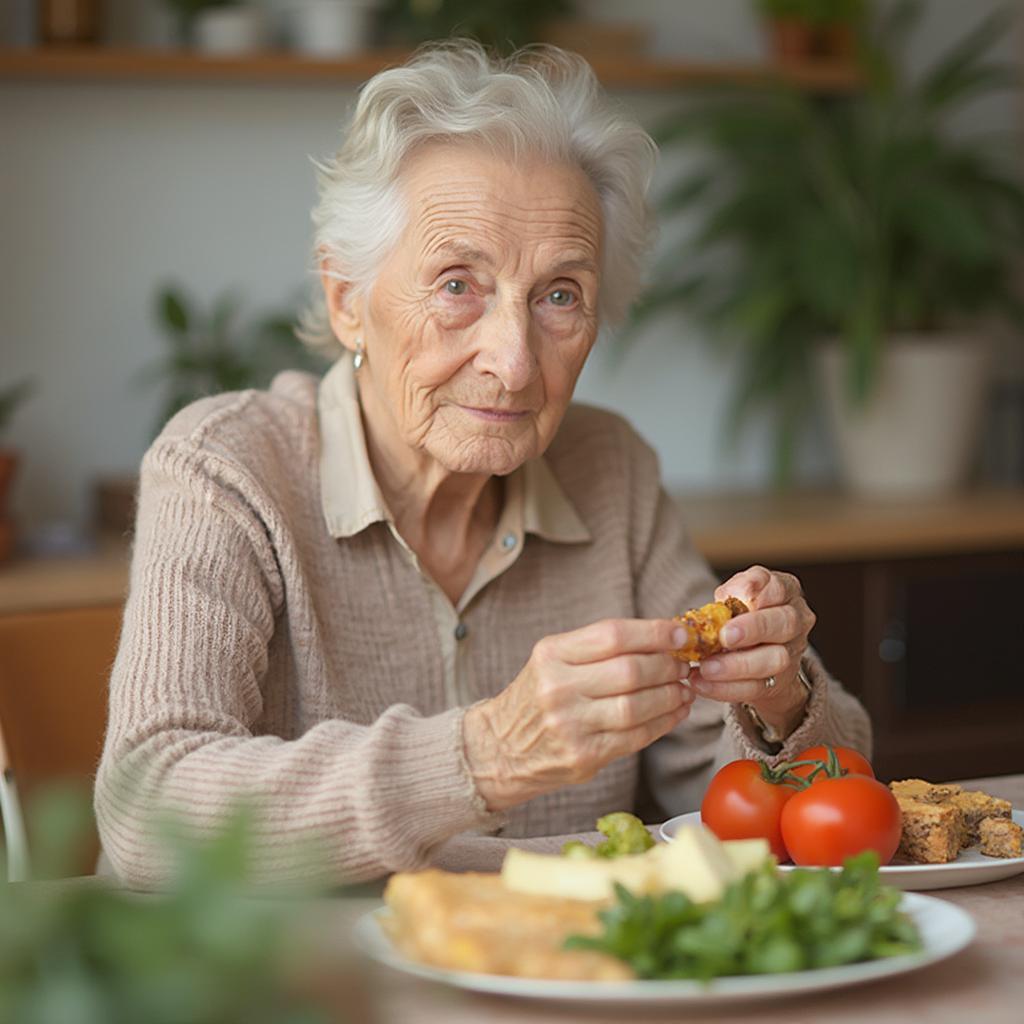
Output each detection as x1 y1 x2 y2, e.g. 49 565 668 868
0 792 367 1024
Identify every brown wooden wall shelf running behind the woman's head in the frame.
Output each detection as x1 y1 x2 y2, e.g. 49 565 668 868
0 47 857 92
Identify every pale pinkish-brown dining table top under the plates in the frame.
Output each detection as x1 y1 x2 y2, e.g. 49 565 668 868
22 770 1024 1024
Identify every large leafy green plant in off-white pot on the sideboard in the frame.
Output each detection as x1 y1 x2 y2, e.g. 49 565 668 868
641 0 1024 492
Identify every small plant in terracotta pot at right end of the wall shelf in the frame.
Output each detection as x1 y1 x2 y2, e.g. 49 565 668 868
757 0 866 61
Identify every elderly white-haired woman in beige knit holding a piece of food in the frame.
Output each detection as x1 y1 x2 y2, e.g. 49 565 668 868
96 44 869 885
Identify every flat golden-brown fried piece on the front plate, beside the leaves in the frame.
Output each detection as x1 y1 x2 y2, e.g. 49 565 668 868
384 869 633 981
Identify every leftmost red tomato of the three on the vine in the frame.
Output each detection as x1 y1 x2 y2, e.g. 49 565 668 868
700 761 796 860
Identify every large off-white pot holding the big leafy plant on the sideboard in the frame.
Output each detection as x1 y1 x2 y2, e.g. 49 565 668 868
816 334 991 498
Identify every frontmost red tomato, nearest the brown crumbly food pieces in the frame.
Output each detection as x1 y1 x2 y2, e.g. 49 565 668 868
781 775 902 866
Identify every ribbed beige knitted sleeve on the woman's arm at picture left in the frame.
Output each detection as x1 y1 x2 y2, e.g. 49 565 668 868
95 430 494 888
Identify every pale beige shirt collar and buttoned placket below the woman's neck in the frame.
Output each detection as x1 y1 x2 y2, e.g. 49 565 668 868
317 357 592 707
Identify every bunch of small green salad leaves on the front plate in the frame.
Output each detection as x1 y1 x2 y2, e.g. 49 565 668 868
565 851 922 981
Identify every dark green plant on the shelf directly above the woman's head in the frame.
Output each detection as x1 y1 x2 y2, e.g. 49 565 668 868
384 0 572 50
